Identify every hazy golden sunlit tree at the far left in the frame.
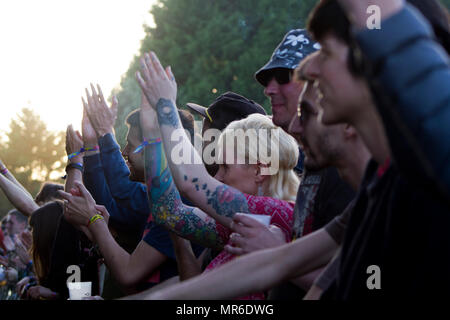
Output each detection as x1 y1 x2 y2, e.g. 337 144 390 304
0 108 66 216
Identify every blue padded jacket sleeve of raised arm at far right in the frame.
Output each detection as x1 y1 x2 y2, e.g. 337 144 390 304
356 5 450 197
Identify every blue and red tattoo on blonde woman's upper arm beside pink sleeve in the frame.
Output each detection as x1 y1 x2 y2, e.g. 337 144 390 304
206 185 249 217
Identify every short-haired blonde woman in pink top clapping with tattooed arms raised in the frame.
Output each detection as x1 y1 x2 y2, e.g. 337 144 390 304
137 53 299 299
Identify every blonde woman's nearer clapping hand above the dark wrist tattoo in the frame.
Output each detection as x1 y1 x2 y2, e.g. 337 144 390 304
136 52 177 109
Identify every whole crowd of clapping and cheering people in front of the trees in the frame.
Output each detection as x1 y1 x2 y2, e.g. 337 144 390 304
0 0 450 300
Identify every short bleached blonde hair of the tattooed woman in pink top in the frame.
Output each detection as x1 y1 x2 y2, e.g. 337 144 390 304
217 114 300 201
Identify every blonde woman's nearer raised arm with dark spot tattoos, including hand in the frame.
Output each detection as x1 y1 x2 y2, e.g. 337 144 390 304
137 53 248 227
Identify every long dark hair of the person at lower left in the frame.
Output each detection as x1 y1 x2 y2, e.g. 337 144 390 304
30 201 63 283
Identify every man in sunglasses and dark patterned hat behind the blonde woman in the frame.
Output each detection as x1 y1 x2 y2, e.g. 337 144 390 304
221 29 354 300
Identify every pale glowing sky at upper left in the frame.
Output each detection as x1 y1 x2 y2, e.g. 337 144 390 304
0 0 155 131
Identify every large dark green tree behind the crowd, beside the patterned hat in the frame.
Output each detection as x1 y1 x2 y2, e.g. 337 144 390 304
114 0 317 145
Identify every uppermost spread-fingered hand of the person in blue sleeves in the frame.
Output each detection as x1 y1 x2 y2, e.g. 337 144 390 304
83 84 119 138
